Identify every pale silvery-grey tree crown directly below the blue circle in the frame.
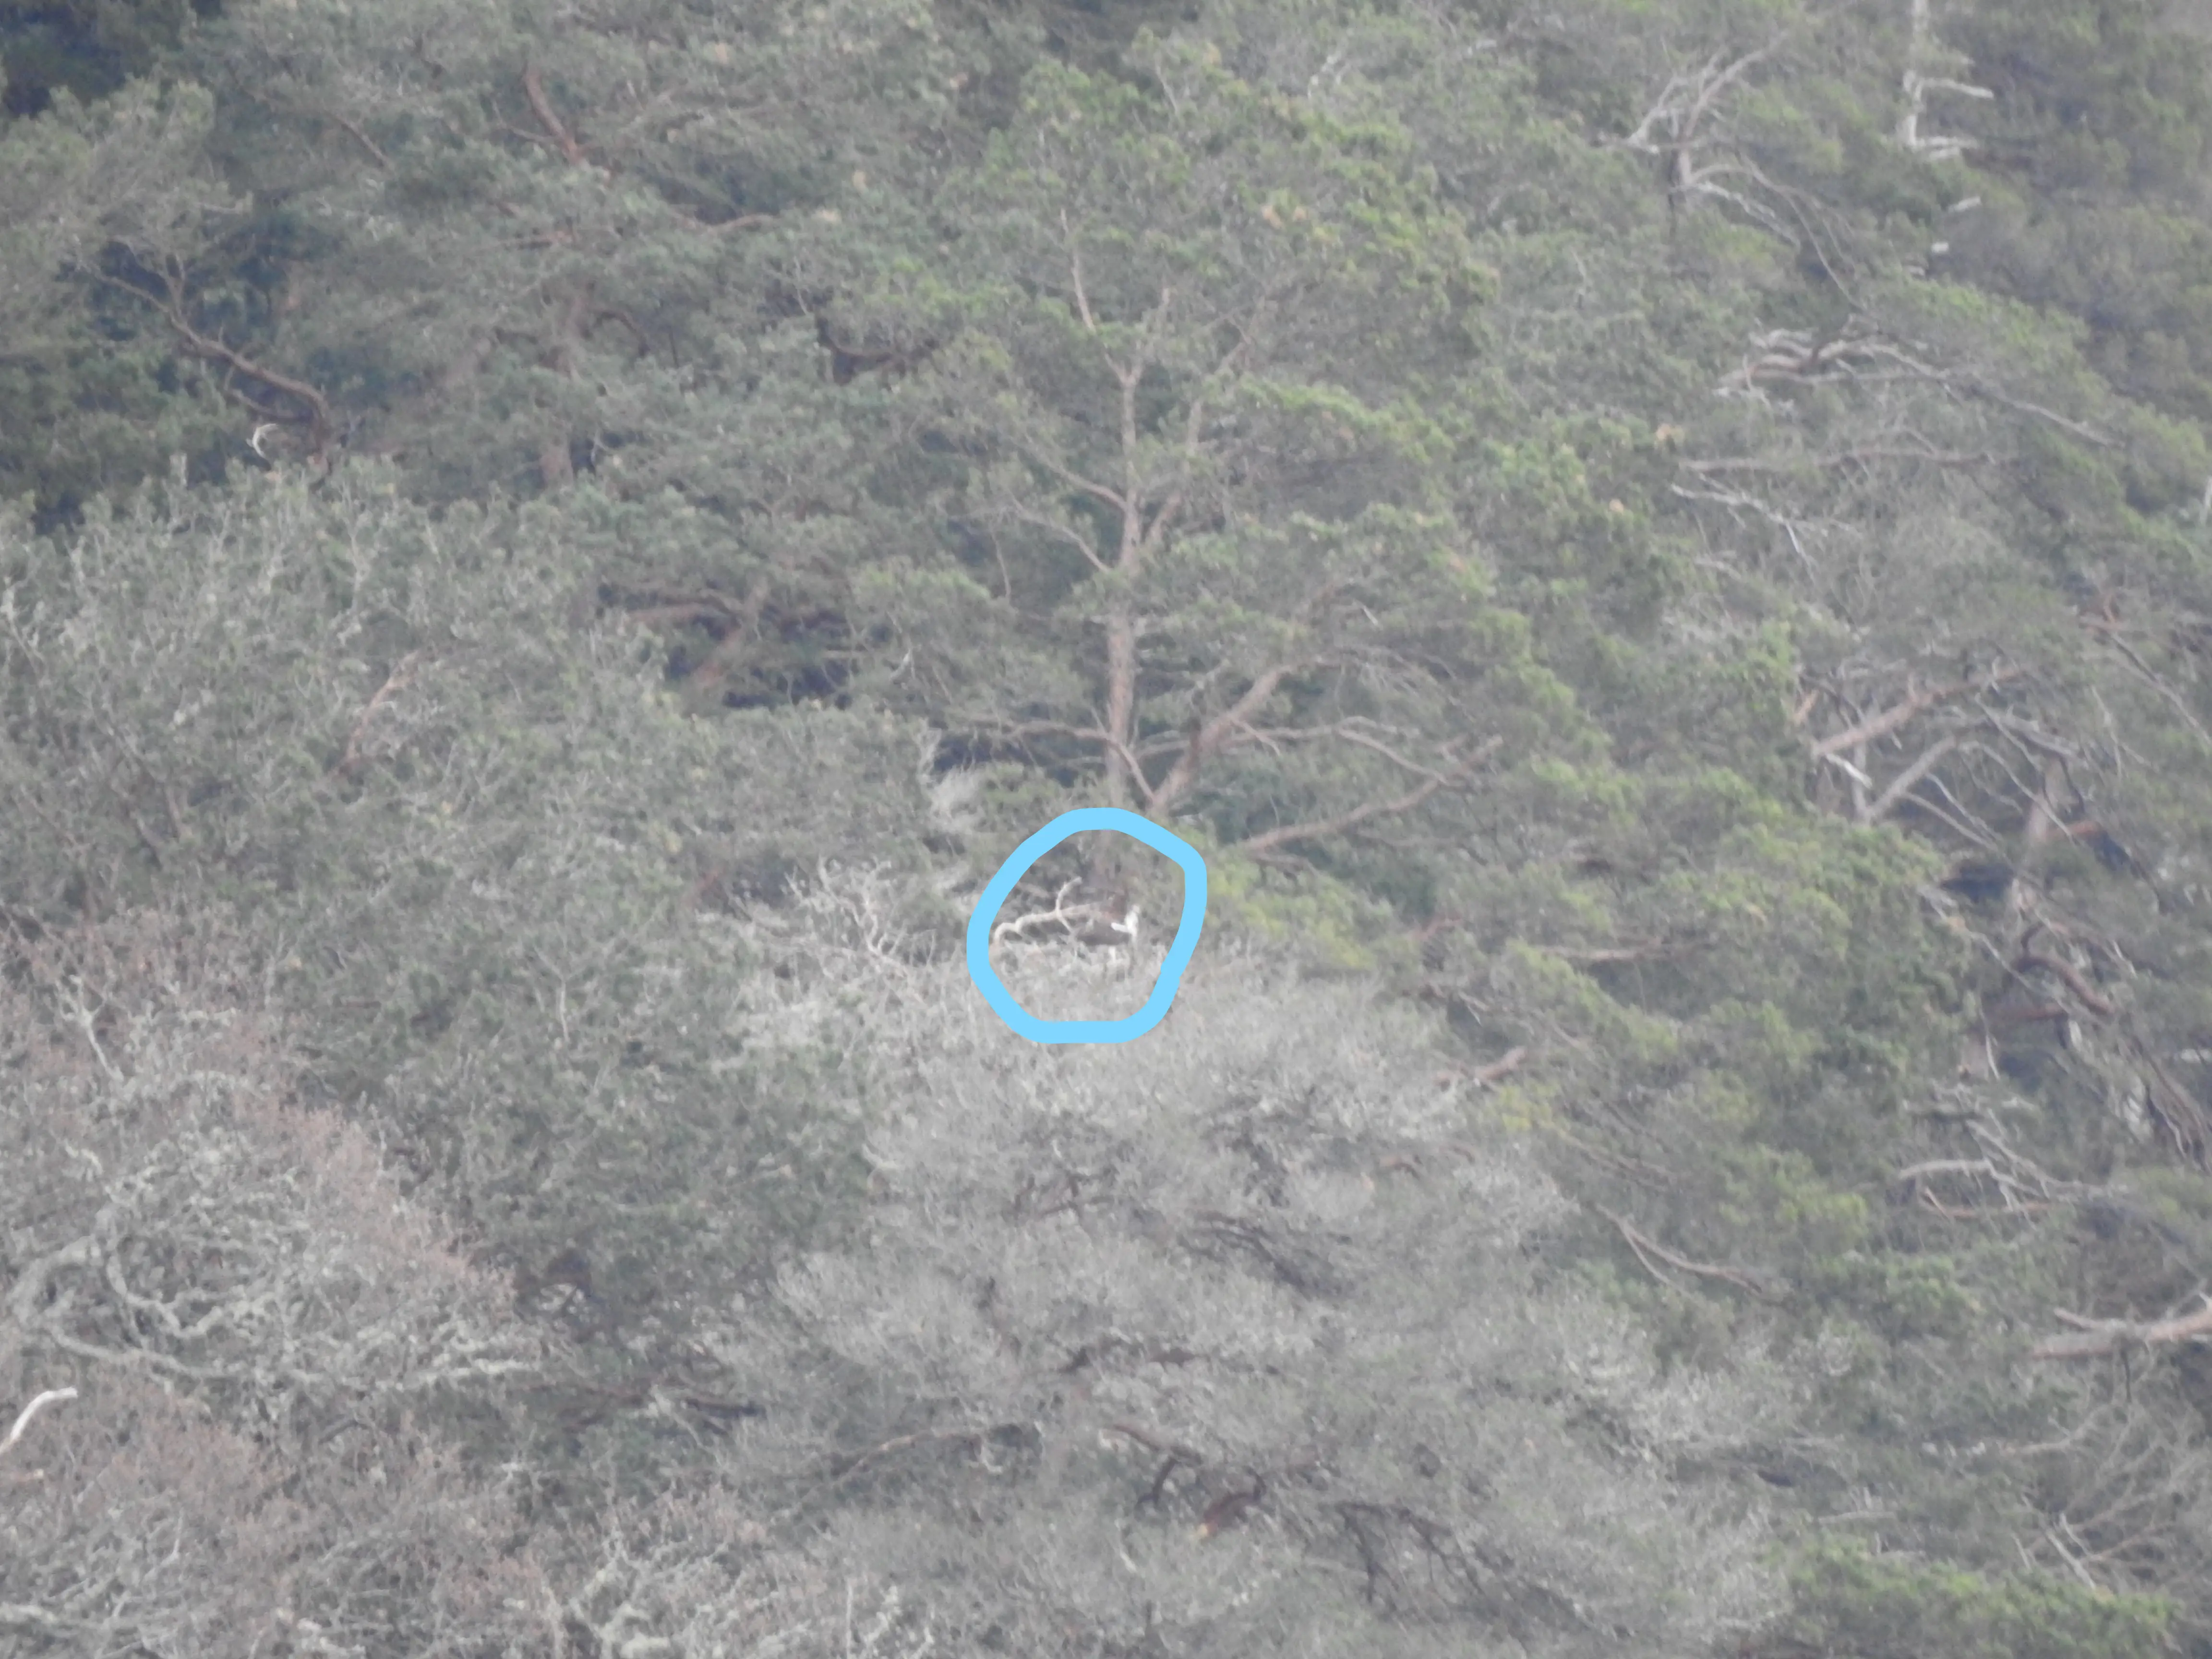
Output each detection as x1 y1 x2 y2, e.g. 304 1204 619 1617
685 898 1790 1655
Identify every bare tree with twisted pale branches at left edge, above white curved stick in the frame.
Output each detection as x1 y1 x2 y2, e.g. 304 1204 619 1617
0 909 533 1453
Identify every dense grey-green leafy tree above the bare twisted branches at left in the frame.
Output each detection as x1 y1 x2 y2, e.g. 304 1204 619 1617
0 476 942 1349
